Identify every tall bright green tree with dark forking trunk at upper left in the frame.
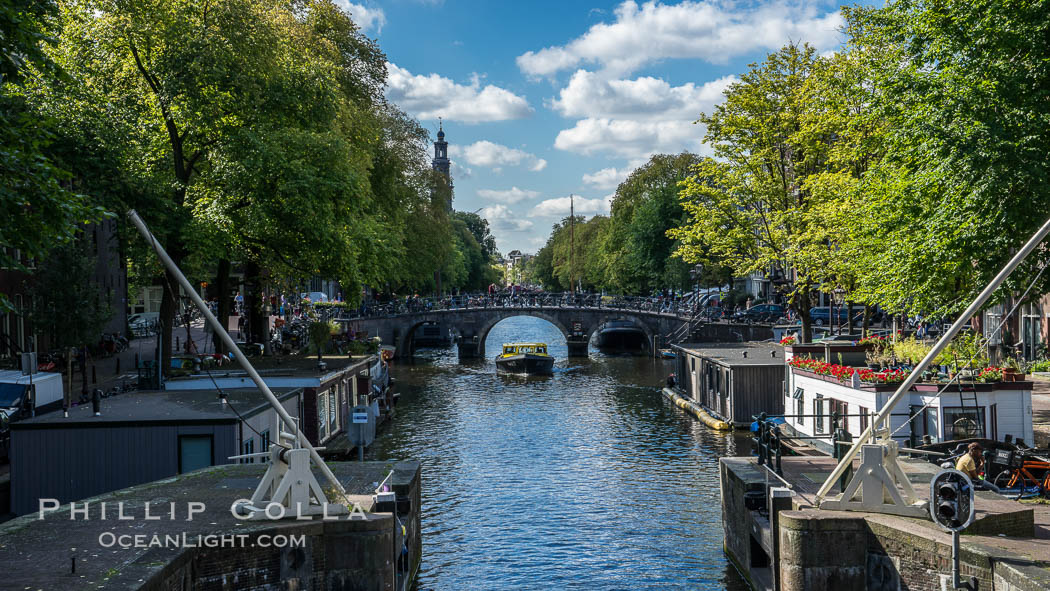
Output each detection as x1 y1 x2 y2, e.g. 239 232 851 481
44 0 309 367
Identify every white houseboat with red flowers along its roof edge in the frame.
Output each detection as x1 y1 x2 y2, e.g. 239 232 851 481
771 342 1032 453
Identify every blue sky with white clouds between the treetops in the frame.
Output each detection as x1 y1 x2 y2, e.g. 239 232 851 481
337 0 842 253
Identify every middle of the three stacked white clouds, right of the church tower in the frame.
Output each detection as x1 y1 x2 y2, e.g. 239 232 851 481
550 70 738 121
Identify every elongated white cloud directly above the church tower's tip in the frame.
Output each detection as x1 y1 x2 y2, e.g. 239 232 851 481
386 63 532 123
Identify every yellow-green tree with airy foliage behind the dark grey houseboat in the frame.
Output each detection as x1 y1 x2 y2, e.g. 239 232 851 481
670 44 830 339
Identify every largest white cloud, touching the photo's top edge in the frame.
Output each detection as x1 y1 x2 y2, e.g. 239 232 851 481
518 0 843 77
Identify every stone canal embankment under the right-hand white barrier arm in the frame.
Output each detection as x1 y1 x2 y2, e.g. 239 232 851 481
719 458 1050 591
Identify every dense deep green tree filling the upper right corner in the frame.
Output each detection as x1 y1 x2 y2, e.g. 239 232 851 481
844 0 1050 314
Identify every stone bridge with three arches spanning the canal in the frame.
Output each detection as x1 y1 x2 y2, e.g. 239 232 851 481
339 307 773 359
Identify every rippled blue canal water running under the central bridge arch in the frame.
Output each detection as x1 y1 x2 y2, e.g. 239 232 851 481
370 317 748 591
